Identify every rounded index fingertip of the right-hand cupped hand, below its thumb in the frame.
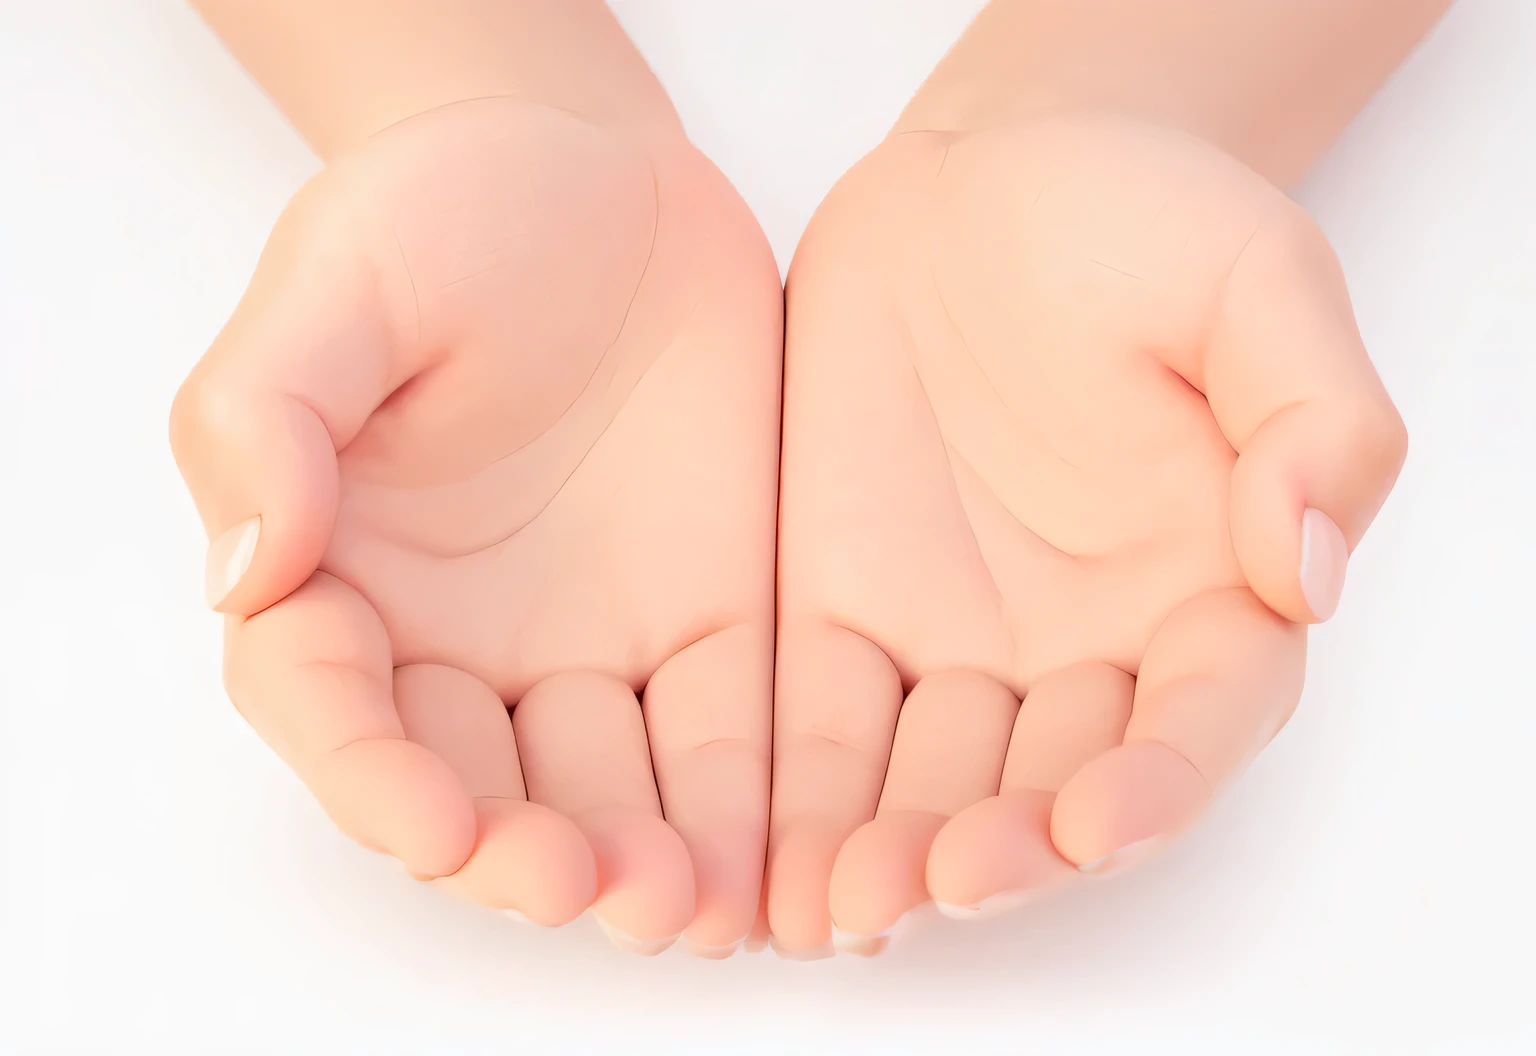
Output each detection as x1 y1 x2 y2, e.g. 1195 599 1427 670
1051 741 1212 872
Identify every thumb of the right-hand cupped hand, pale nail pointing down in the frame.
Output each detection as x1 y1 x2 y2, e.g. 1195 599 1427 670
1198 210 1407 623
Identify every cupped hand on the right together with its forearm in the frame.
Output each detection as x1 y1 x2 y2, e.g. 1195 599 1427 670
768 0 1445 958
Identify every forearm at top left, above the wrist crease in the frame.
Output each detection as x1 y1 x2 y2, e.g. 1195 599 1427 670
192 0 677 158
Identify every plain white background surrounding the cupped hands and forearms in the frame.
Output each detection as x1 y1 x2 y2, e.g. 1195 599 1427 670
0 0 1536 1054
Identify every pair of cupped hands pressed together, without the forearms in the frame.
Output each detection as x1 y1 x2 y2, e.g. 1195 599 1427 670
172 98 1405 958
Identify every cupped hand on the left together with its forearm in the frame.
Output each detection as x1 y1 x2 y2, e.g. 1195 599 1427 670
172 0 782 956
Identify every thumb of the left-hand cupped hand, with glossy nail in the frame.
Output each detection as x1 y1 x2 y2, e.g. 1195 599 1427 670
170 175 399 615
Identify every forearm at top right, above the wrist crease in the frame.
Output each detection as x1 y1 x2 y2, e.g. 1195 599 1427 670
897 0 1450 187
